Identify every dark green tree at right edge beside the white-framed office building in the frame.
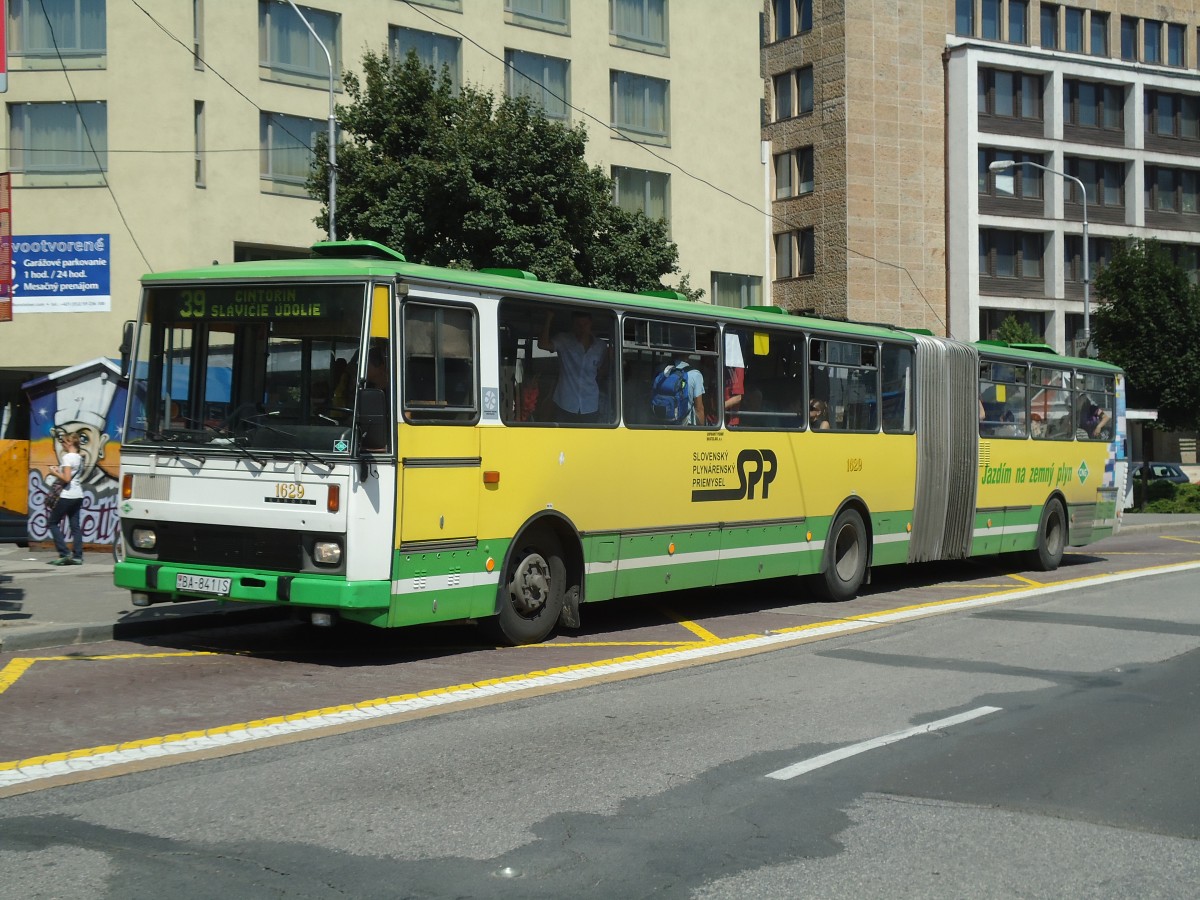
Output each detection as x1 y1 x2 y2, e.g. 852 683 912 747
1092 240 1200 431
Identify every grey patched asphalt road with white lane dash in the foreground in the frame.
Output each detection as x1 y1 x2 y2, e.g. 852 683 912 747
0 551 1200 899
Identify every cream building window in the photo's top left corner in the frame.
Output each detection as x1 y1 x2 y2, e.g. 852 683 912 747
7 0 107 62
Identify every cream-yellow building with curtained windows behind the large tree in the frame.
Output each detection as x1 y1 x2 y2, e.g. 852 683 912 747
0 0 767 386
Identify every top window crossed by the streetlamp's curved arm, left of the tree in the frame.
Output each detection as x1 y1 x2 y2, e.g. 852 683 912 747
258 0 342 85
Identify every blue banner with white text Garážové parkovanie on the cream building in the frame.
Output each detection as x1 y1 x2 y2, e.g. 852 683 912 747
12 234 113 313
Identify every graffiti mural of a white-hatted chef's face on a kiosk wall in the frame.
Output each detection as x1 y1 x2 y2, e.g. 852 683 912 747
24 359 125 544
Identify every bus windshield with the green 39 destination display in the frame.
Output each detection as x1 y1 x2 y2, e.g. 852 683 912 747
125 283 367 456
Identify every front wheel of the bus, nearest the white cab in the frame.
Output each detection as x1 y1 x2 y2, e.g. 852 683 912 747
490 532 566 647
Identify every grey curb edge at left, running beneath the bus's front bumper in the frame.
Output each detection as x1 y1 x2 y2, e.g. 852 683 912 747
0 606 285 653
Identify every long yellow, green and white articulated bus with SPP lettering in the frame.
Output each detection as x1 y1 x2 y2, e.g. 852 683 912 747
114 241 1124 643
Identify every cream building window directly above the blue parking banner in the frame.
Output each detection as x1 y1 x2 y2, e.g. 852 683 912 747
8 102 108 175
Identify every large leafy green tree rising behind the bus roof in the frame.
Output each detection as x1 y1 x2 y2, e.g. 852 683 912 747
308 52 703 299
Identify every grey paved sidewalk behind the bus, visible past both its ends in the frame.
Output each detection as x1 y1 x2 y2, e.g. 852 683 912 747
0 514 1200 653
